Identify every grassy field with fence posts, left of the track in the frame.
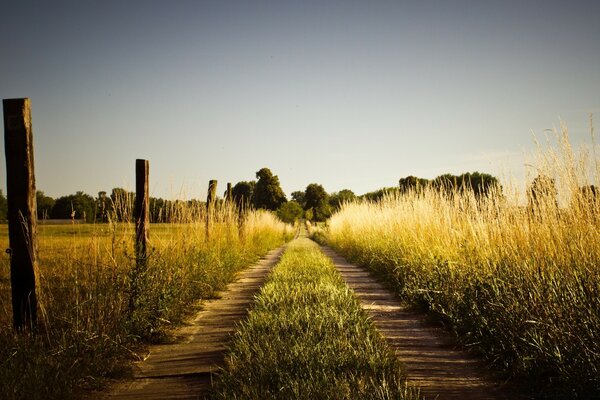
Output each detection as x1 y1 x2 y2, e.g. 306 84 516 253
0 208 292 399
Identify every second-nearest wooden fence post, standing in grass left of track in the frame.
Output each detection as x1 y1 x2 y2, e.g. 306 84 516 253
129 159 150 312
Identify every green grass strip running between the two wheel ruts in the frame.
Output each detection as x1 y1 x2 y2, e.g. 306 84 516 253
215 238 417 399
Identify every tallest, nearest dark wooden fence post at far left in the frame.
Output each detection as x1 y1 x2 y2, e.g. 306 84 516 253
2 98 37 332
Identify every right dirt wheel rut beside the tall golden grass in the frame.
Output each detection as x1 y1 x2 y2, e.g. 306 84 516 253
321 246 517 400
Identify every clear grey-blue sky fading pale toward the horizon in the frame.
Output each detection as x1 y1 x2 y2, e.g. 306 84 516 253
0 0 600 198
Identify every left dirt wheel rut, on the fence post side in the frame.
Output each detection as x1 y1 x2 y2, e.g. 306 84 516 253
99 247 284 400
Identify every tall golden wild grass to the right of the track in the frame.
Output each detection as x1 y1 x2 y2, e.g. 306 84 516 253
325 130 600 398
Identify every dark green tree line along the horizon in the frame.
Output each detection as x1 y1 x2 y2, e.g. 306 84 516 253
0 168 598 222
